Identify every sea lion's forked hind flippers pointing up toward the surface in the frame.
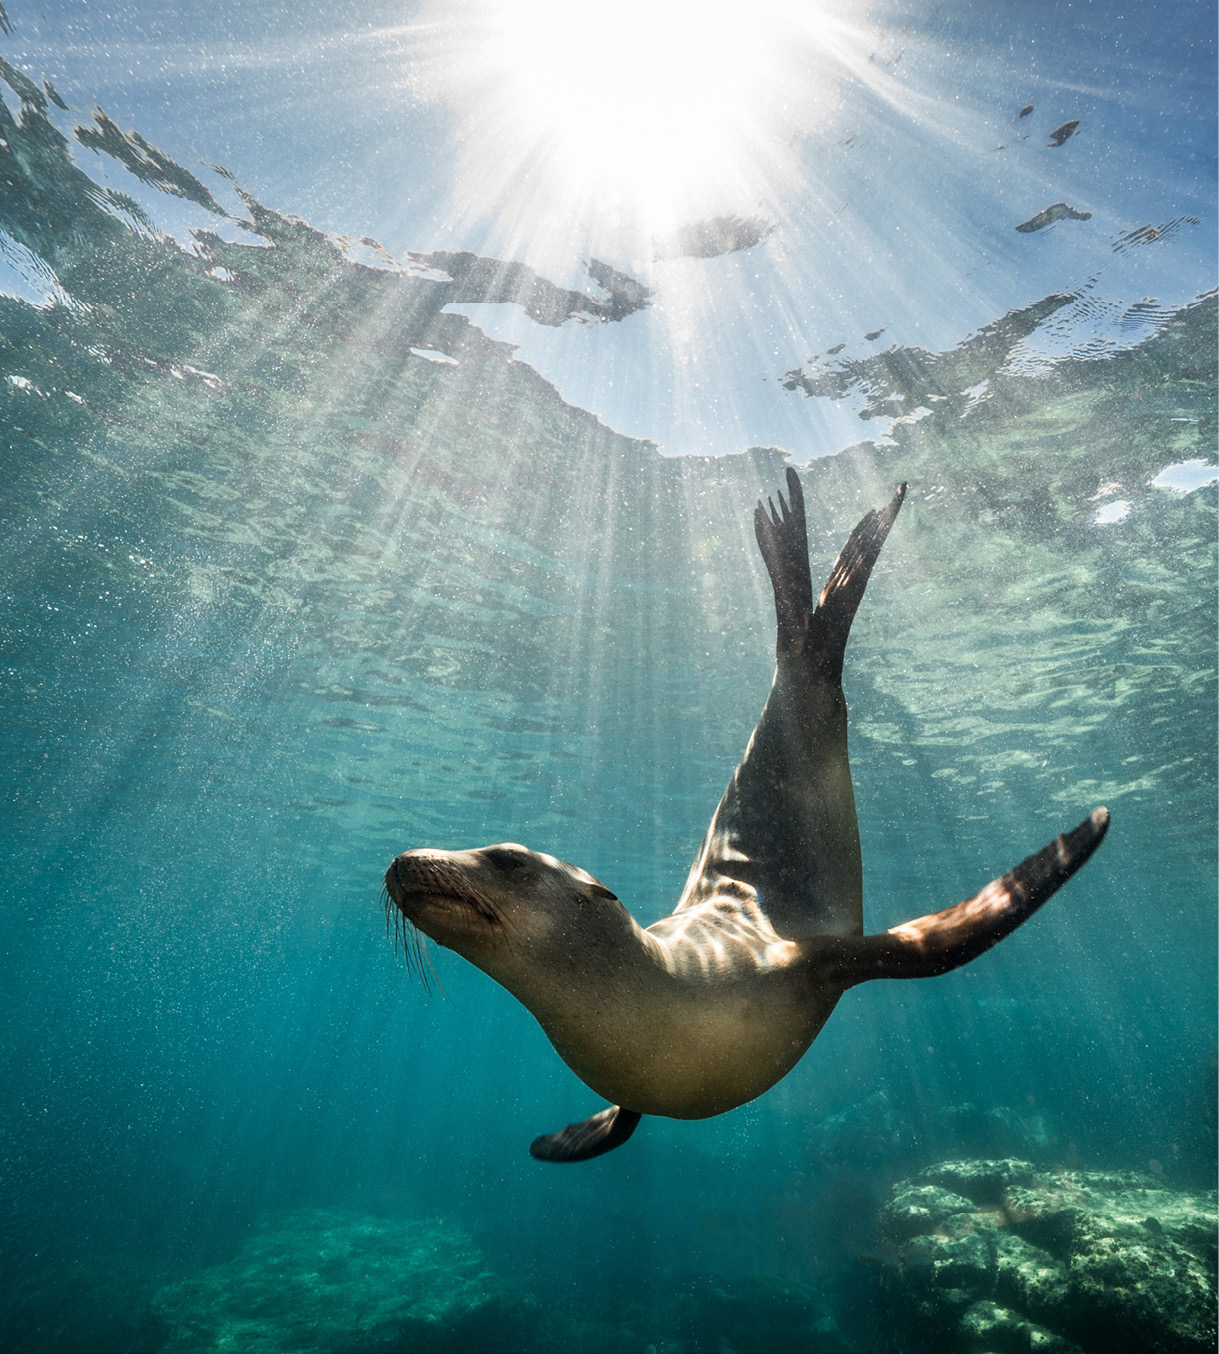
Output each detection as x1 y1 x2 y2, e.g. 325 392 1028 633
753 466 906 680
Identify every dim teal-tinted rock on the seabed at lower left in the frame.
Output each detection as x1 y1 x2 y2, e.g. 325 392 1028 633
153 1210 536 1354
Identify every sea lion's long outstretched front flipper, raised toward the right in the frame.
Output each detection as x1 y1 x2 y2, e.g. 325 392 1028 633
824 808 1109 987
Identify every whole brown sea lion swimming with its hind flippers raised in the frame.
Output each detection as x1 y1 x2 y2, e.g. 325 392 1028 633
385 470 1109 1162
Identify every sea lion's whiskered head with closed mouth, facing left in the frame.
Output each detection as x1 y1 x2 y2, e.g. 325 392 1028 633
385 842 633 999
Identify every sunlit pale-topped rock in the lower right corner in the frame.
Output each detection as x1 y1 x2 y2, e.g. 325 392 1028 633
879 1158 1216 1354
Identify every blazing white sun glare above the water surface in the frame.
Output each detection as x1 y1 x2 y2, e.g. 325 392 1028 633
412 0 837 254
